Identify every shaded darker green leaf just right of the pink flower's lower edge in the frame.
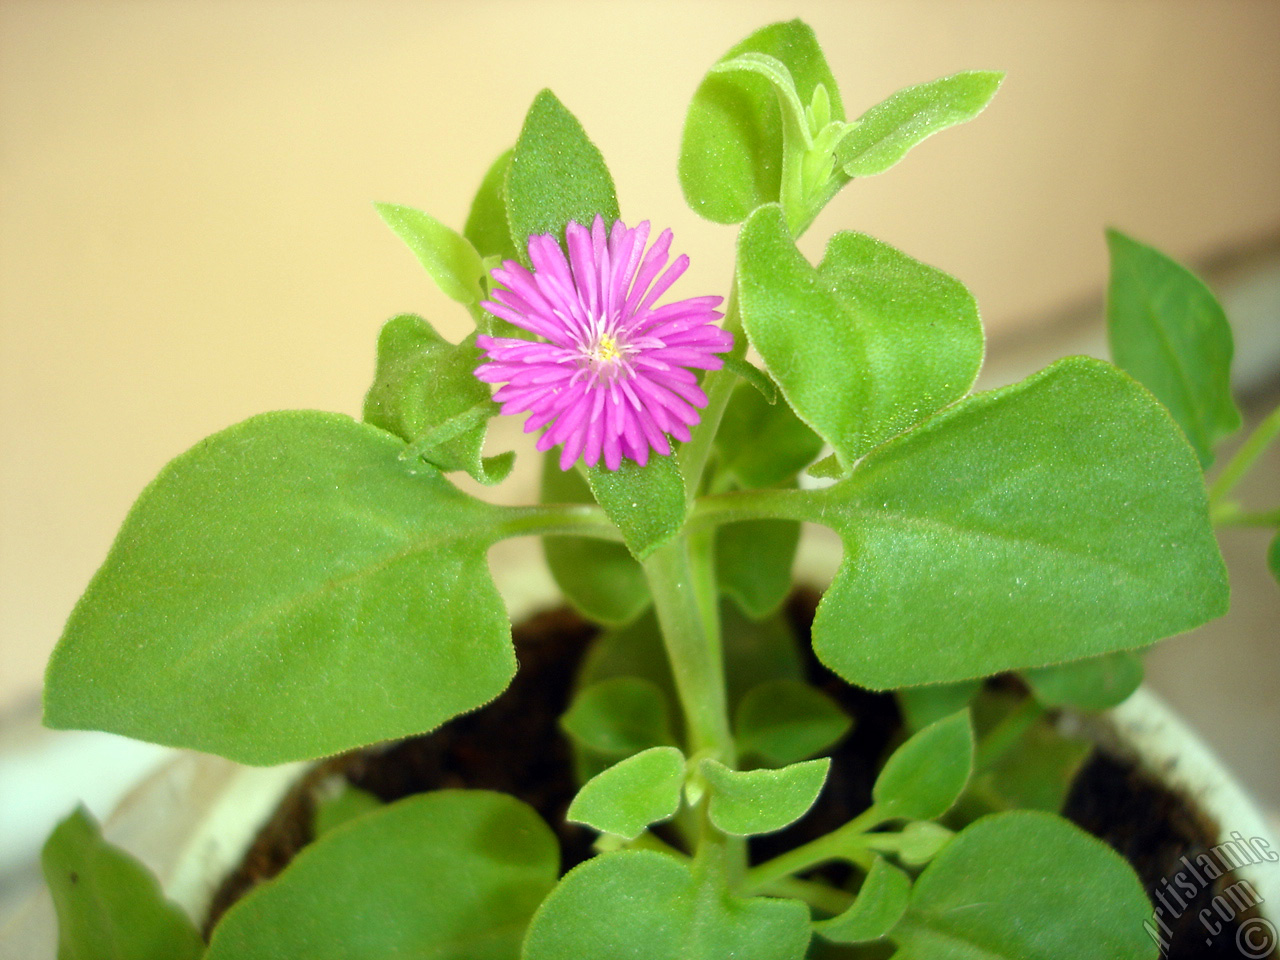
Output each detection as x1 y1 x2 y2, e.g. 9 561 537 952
716 384 822 489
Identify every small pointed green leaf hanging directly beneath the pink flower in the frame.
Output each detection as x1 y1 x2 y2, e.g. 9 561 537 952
586 454 689 561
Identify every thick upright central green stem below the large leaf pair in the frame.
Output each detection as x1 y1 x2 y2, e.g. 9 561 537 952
644 536 733 764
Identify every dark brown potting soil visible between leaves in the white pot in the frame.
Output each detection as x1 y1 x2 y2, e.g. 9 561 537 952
205 591 1275 960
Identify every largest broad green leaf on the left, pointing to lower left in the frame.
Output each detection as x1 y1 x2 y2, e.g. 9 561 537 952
45 411 516 764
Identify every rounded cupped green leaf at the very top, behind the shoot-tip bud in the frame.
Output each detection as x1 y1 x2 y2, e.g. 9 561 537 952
680 20 845 223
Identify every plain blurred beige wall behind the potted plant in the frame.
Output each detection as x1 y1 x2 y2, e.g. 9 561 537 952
0 0 1280 714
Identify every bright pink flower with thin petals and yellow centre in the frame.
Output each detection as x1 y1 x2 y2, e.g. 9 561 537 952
476 216 733 470
